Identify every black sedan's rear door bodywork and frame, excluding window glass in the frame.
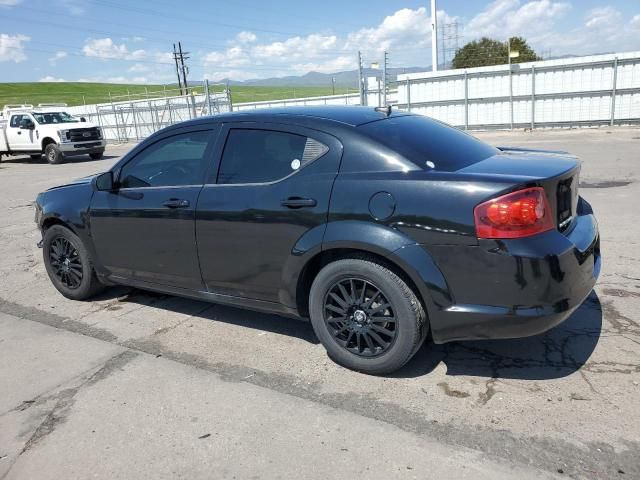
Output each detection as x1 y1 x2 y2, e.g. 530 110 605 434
196 122 342 307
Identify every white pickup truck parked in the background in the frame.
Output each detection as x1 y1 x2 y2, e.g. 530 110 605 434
0 104 107 164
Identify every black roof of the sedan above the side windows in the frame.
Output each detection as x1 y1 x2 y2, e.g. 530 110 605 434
172 105 410 127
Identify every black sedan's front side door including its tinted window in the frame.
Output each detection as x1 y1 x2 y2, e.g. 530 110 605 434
90 127 219 290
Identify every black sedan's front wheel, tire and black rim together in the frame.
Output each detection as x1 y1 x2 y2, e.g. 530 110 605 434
42 225 104 300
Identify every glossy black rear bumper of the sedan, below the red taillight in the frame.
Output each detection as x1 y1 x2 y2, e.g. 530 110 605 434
429 214 601 343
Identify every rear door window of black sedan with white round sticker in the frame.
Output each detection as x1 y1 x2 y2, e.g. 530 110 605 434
218 128 329 184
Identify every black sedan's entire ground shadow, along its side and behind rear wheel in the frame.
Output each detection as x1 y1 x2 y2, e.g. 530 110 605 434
97 287 602 380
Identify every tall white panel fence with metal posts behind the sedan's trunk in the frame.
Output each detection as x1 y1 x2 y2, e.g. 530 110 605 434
397 52 640 128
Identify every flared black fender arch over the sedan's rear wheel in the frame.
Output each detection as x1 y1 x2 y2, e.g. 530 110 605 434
280 220 453 314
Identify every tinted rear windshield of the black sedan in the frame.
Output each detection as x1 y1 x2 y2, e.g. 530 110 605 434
359 115 498 172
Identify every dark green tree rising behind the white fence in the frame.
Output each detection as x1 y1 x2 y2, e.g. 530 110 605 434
451 37 542 68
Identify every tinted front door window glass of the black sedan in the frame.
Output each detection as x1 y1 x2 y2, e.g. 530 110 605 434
120 131 210 188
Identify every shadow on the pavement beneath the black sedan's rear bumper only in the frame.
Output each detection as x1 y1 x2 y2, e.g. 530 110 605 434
393 291 602 380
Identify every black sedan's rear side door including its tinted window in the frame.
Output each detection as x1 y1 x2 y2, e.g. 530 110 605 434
196 123 342 303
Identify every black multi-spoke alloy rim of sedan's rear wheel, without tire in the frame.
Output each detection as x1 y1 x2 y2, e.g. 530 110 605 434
324 278 398 357
